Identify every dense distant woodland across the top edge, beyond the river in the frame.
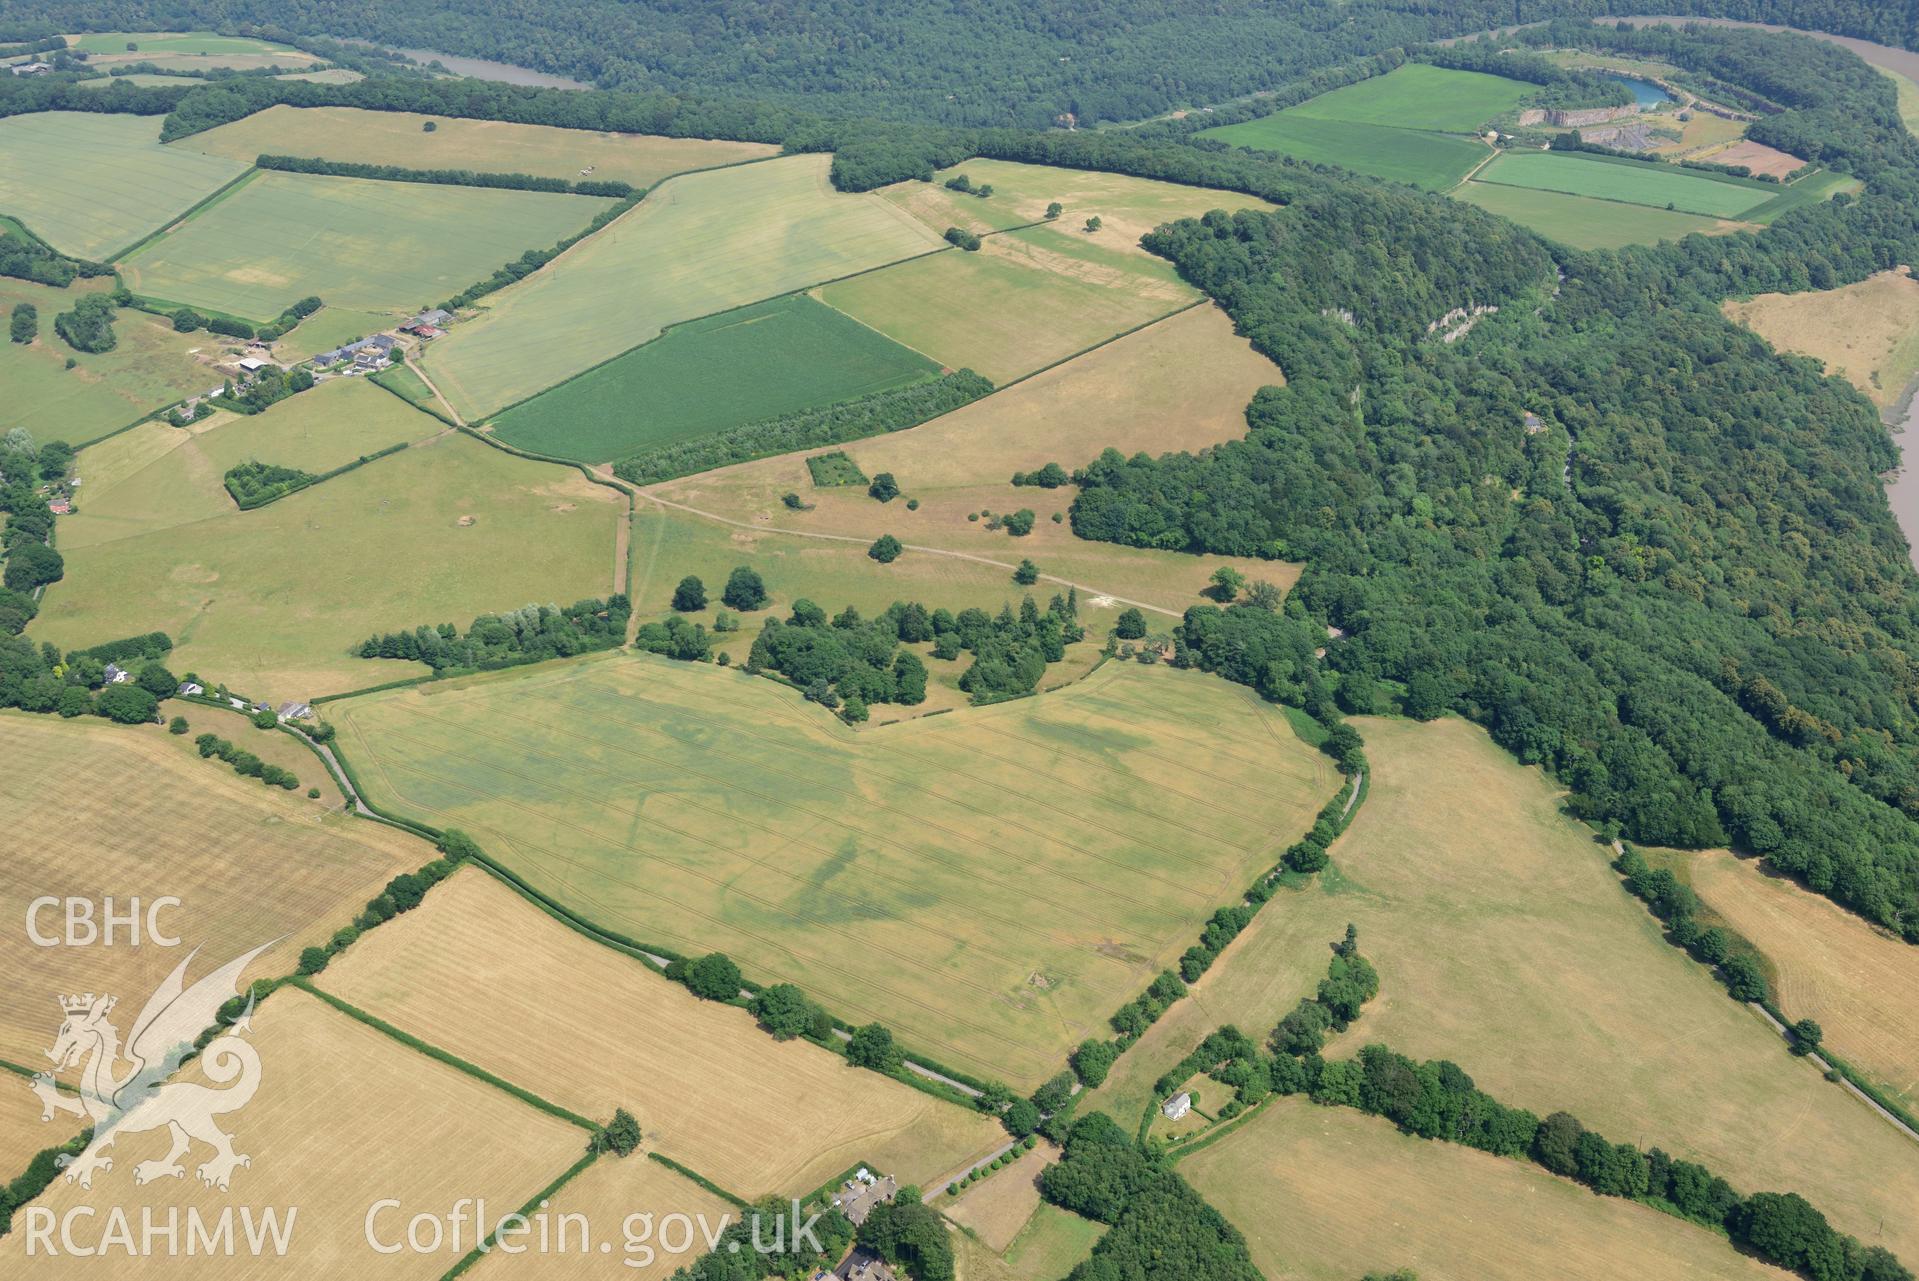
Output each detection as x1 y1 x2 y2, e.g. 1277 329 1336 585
0 0 1919 127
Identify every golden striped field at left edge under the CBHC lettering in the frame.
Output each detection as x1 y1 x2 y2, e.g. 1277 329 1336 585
0 717 420 1066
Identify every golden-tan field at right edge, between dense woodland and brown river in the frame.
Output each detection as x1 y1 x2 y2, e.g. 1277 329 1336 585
1725 267 1919 408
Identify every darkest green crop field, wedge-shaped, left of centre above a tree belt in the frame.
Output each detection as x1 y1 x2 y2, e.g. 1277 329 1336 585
493 293 940 462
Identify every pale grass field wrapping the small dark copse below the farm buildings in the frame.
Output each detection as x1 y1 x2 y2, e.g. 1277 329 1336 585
59 378 443 550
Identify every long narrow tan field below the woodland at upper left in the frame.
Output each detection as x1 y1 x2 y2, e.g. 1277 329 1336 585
177 105 779 186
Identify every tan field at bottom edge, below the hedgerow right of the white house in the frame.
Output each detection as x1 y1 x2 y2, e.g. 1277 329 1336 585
1180 1099 1783 1281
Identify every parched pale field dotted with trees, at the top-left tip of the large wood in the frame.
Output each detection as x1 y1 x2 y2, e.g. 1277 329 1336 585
881 159 1270 257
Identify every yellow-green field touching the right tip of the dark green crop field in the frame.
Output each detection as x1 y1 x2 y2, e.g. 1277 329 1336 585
819 226 1199 384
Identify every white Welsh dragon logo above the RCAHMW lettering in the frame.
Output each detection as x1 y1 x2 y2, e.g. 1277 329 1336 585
33 940 278 1191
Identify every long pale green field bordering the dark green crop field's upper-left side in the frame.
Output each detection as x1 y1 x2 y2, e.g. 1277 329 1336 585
426 155 944 418
